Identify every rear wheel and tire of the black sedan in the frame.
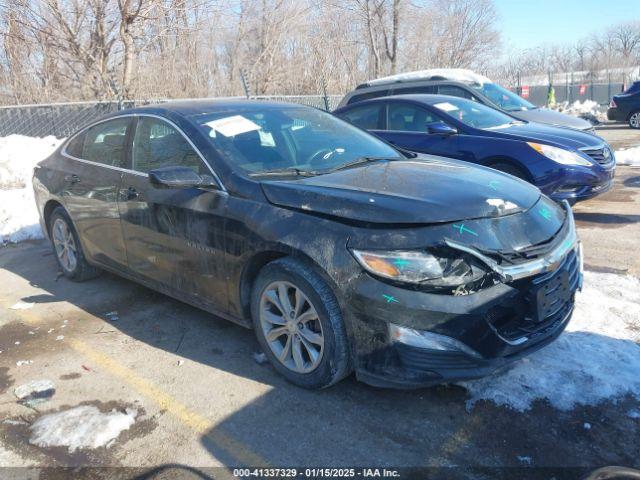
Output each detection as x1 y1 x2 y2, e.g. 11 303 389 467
49 207 100 281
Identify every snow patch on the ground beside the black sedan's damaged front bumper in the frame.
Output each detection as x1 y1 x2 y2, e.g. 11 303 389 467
462 272 640 411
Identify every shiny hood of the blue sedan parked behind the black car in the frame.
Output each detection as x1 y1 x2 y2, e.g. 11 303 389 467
484 123 605 150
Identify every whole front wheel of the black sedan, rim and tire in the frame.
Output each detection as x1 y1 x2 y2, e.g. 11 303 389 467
251 258 351 388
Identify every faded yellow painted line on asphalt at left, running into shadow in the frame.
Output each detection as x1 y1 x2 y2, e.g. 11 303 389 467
69 339 269 467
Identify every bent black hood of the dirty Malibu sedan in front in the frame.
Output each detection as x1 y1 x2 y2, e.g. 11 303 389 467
261 156 540 224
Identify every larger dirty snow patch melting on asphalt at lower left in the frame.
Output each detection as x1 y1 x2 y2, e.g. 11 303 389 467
29 405 137 452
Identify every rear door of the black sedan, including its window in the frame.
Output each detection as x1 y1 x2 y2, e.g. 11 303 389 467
60 117 131 270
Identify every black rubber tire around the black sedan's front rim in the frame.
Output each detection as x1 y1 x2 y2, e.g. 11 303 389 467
251 258 352 389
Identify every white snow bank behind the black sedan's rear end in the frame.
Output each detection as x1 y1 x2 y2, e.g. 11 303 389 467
0 135 62 245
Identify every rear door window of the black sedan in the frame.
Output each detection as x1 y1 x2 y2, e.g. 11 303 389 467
75 117 130 168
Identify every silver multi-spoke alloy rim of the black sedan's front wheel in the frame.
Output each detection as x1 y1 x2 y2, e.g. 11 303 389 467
260 281 324 373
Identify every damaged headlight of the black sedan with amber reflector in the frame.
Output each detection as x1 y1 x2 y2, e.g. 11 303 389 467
352 250 486 287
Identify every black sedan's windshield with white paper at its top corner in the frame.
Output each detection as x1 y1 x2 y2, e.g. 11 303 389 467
195 102 402 176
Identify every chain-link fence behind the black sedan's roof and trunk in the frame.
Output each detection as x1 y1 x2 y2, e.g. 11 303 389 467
0 95 342 138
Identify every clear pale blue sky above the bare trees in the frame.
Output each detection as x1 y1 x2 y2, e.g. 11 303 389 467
494 0 640 50
